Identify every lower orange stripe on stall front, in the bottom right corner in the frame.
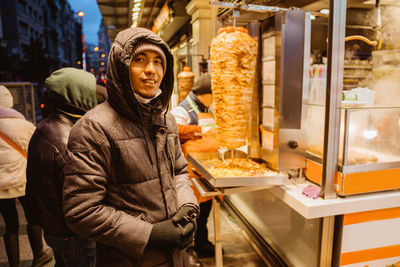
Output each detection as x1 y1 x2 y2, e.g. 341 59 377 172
340 245 400 266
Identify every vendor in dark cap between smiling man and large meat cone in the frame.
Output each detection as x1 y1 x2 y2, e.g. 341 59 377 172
171 73 218 258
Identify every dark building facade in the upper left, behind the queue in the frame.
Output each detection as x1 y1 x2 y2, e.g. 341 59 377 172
0 0 82 81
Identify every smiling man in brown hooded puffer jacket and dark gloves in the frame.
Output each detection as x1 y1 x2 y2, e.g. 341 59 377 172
63 28 199 267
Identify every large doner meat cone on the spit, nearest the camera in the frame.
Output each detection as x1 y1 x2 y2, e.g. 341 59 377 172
210 26 257 149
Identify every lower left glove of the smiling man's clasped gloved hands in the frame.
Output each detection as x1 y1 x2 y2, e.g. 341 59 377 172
148 220 196 249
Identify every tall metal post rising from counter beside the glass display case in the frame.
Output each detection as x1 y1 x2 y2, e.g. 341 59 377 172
321 0 346 199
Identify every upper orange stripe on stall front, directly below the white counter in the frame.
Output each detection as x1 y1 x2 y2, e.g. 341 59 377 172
343 208 400 225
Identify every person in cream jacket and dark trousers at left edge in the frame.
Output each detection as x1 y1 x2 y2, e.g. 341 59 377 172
0 86 53 267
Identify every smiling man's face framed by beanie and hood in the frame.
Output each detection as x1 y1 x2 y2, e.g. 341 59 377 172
130 51 164 98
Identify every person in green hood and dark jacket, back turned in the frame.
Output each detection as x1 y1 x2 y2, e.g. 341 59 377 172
26 68 97 267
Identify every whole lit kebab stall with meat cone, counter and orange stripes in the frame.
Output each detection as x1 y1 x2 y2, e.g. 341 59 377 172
188 0 400 267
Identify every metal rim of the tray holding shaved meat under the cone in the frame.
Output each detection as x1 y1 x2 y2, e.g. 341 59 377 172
188 153 290 187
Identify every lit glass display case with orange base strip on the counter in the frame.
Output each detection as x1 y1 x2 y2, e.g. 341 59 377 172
306 105 400 196
